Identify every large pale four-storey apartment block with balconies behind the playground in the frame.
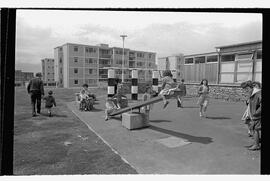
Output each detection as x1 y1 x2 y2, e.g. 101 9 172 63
54 43 156 88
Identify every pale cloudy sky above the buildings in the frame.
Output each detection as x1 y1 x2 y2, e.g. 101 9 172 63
15 10 262 72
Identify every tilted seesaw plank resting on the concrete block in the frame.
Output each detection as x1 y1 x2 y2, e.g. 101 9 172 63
109 89 182 116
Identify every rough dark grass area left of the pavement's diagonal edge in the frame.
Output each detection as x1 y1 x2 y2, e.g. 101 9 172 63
14 88 137 175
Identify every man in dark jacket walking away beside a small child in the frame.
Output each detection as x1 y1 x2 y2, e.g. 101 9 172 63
27 73 44 117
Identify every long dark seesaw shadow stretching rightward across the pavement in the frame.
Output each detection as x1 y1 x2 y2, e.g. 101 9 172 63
148 125 213 144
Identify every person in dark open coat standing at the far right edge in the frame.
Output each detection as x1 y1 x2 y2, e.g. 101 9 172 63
241 82 262 151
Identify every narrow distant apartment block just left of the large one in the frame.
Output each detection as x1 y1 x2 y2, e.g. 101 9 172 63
41 58 55 86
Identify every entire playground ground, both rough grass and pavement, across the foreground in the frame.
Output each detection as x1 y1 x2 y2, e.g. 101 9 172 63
14 89 260 175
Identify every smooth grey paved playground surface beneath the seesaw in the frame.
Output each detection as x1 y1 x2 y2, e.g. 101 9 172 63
67 93 260 174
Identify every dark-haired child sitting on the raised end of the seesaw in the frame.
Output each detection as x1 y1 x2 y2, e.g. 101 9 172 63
159 70 177 109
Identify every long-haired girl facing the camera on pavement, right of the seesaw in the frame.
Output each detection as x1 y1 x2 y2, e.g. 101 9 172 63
198 79 209 117
